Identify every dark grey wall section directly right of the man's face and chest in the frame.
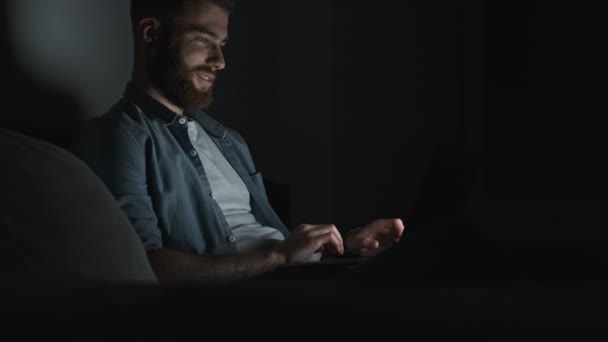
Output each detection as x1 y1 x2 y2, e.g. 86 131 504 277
210 0 335 224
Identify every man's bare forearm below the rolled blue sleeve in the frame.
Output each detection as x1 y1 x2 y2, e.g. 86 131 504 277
148 249 285 284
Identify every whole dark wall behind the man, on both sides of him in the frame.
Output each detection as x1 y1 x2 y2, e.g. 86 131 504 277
3 0 608 239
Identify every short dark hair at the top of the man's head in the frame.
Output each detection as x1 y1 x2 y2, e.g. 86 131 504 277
131 0 236 28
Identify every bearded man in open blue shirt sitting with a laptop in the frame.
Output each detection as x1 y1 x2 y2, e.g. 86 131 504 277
75 0 404 283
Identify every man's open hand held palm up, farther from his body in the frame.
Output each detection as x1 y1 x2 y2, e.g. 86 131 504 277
344 219 405 256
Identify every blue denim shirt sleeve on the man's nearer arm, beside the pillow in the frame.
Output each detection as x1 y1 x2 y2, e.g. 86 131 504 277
74 121 163 251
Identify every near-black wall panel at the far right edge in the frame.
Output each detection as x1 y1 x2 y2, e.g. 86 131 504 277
483 1 608 239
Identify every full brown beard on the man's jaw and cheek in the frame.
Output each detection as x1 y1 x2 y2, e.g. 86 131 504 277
149 44 213 111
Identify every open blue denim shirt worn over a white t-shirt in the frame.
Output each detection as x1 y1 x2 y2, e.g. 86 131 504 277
74 86 288 255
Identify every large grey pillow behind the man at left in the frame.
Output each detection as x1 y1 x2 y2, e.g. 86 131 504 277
0 129 157 284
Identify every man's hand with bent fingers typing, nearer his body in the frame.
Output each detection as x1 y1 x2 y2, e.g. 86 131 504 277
275 224 344 263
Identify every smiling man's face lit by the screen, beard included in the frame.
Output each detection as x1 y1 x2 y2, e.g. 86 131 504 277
148 1 228 111
